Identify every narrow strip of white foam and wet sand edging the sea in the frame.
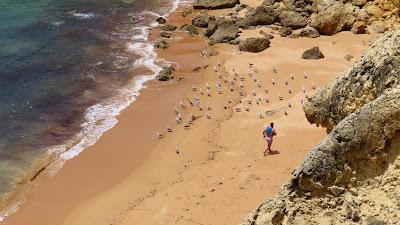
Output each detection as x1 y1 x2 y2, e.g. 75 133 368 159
0 0 200 223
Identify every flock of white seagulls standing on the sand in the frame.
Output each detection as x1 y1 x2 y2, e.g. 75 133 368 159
156 60 319 154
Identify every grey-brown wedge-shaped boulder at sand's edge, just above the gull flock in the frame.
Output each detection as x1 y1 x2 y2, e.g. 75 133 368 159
209 19 239 45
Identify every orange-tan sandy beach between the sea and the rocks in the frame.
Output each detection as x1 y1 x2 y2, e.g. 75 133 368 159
3 2 382 225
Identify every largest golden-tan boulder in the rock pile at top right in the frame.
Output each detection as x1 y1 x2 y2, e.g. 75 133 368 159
311 2 356 35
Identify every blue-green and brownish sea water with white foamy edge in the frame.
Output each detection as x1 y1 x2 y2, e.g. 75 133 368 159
0 0 183 217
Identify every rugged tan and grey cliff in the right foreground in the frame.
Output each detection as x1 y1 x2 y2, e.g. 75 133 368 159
243 29 400 225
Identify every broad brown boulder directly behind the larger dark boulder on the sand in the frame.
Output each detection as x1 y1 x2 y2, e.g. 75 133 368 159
238 6 278 27
